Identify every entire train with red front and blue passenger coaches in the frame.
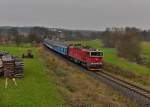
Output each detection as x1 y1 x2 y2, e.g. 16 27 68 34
43 39 103 71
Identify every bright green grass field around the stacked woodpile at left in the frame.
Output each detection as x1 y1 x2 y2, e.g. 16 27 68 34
0 46 64 107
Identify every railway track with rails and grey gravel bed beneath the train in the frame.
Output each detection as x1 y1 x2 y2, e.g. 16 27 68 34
43 45 150 107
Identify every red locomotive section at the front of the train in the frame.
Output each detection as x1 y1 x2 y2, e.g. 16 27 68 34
68 46 103 70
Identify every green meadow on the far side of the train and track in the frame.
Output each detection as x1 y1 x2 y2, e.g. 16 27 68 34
66 39 150 75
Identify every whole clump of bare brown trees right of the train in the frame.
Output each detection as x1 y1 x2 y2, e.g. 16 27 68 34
101 27 142 63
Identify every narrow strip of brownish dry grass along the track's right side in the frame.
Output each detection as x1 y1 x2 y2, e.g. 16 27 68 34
103 62 150 89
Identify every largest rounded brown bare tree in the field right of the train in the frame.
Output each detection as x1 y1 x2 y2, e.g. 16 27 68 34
116 28 141 63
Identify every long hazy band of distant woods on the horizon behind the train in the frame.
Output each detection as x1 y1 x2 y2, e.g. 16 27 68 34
0 26 101 44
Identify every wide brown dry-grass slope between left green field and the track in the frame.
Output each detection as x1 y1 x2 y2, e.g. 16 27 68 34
39 47 137 107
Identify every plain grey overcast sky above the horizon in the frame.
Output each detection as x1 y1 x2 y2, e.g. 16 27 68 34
0 0 150 30
